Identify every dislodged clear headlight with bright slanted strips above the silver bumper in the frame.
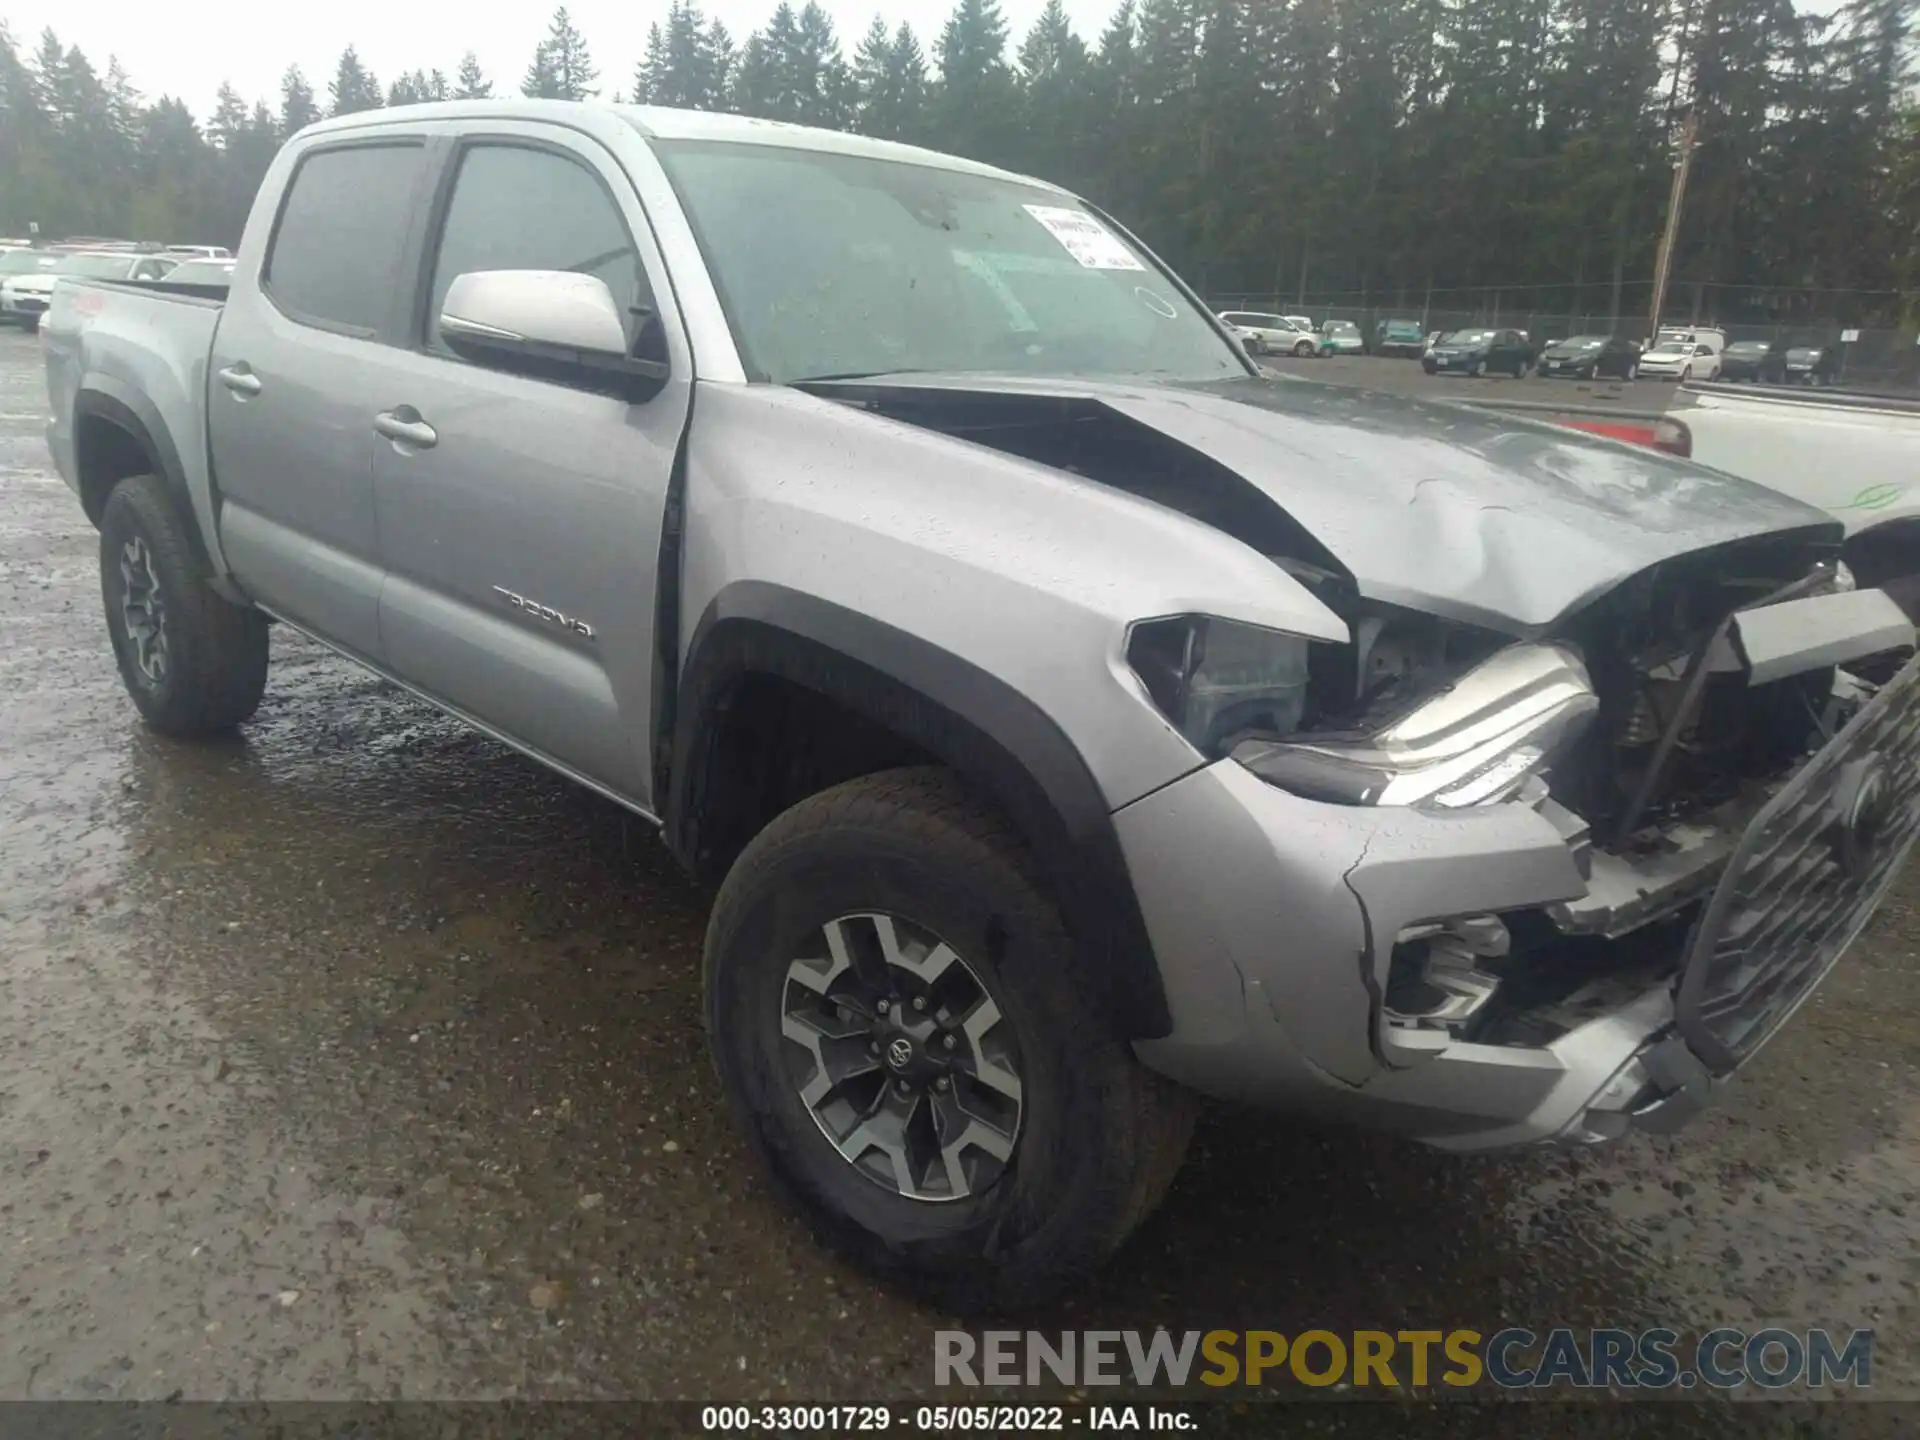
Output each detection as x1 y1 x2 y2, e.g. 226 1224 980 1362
1233 643 1599 808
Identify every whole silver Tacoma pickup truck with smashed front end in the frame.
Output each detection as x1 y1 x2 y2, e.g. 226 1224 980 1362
46 102 1920 1304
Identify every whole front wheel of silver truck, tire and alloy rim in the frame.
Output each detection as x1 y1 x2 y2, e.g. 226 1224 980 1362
707 768 1194 1309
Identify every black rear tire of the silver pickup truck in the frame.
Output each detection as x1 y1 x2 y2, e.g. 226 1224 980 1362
100 474 267 737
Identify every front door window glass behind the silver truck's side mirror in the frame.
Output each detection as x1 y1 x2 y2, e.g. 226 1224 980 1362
426 144 666 359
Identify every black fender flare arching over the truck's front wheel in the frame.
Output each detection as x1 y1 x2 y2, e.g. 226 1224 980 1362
662 582 1173 1039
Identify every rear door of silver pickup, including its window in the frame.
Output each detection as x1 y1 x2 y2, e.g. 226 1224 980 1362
207 131 428 659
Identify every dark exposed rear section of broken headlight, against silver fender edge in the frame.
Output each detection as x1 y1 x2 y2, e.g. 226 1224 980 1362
1127 614 1308 760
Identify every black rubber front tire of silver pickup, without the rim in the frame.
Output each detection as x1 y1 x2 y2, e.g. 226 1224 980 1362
705 768 1196 1311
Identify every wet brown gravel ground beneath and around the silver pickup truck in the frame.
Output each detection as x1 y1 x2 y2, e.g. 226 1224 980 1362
0 332 1920 1432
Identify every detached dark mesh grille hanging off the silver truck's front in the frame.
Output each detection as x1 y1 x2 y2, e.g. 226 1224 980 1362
1674 659 1920 1073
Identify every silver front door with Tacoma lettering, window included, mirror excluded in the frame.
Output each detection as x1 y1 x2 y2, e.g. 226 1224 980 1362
357 121 691 804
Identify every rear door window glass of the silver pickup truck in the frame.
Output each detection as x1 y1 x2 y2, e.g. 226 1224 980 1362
261 144 422 334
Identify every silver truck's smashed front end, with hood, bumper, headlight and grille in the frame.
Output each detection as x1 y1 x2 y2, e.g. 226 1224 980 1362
806 378 1920 1148
